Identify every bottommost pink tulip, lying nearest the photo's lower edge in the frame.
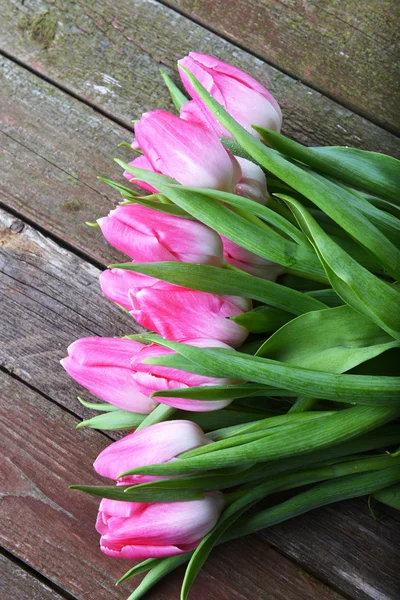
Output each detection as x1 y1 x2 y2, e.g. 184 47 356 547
96 492 224 560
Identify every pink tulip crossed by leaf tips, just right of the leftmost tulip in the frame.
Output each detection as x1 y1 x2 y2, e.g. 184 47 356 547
132 339 235 412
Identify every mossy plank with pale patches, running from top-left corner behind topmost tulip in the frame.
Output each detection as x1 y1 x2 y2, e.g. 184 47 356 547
0 0 399 154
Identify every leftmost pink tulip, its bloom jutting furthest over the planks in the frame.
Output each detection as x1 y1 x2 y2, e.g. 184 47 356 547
61 337 157 414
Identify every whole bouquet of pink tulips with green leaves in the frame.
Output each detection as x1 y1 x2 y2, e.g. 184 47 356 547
62 53 400 600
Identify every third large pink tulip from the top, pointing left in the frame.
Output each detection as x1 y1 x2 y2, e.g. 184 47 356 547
97 204 223 266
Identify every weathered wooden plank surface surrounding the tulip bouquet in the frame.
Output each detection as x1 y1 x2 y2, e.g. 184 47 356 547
0 0 400 600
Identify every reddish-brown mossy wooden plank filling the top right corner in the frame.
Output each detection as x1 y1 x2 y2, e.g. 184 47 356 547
166 0 400 132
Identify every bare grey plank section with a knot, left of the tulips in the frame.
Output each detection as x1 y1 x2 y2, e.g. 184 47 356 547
0 211 140 416
